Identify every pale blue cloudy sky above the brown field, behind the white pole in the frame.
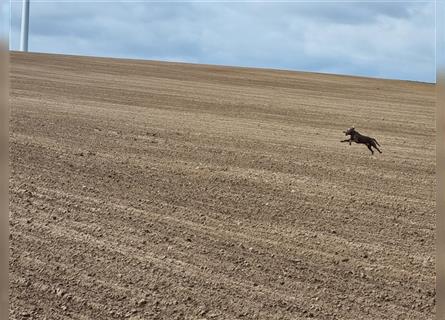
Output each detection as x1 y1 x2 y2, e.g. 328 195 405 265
9 0 436 82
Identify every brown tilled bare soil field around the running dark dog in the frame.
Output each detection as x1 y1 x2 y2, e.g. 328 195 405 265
9 53 435 320
